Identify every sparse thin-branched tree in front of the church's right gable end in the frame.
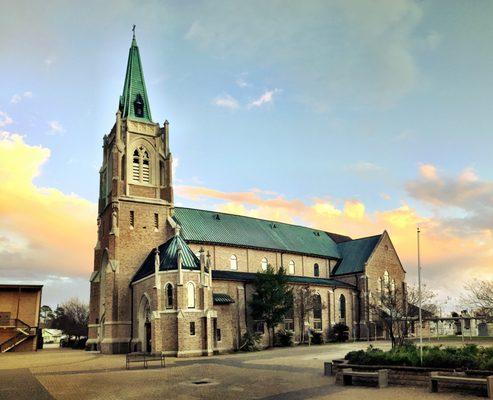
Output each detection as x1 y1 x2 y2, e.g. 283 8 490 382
369 281 407 348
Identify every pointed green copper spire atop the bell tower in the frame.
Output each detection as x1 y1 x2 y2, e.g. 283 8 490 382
119 26 152 122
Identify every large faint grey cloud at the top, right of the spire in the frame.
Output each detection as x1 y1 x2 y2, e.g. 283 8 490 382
185 0 428 110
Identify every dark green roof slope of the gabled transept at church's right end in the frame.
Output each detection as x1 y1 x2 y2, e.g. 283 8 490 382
332 234 383 275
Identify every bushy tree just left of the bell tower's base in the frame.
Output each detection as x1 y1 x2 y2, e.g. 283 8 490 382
52 297 89 339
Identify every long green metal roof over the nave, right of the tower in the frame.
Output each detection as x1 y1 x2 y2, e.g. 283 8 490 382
174 207 340 258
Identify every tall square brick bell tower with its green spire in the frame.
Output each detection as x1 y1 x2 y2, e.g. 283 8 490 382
87 26 173 353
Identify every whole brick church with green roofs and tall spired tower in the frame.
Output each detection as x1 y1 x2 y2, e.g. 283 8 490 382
87 34 406 357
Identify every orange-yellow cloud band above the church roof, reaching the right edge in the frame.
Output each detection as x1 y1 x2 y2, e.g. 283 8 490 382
175 178 493 304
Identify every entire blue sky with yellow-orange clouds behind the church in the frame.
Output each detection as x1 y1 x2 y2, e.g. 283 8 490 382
0 0 493 308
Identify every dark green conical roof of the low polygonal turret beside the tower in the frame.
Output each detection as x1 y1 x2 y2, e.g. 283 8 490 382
132 236 200 282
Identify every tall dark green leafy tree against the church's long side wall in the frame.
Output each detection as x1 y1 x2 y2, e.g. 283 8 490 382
249 265 293 346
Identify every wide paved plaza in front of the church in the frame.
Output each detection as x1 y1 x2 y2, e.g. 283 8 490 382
0 342 488 400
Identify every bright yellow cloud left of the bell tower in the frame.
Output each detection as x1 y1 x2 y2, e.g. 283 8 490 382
0 131 96 280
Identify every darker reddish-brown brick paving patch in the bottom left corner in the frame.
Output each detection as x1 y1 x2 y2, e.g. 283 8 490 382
0 368 54 400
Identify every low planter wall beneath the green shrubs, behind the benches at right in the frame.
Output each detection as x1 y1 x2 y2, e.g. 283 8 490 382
332 360 493 396
